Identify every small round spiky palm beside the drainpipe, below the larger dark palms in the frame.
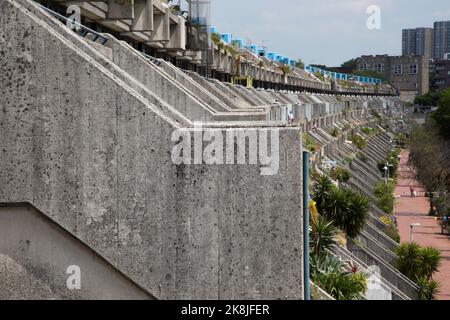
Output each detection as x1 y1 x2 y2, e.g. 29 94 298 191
310 217 337 256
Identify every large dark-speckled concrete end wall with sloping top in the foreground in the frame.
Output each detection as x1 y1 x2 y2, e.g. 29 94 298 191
0 0 303 299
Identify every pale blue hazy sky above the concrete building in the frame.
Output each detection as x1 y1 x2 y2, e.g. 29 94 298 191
211 0 450 66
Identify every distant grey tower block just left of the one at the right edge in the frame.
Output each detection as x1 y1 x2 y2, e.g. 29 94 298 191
402 28 434 59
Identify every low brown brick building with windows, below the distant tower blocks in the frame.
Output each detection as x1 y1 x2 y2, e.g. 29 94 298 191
356 55 430 101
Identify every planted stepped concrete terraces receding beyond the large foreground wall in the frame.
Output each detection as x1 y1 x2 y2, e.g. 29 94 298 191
255 88 417 299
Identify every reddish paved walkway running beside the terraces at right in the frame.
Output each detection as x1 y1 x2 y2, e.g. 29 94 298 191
395 150 450 300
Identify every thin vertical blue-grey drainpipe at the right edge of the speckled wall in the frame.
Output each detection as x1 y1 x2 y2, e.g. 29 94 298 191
303 151 311 300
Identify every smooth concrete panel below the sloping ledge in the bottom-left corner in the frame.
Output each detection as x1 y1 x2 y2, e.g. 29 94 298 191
0 204 152 300
